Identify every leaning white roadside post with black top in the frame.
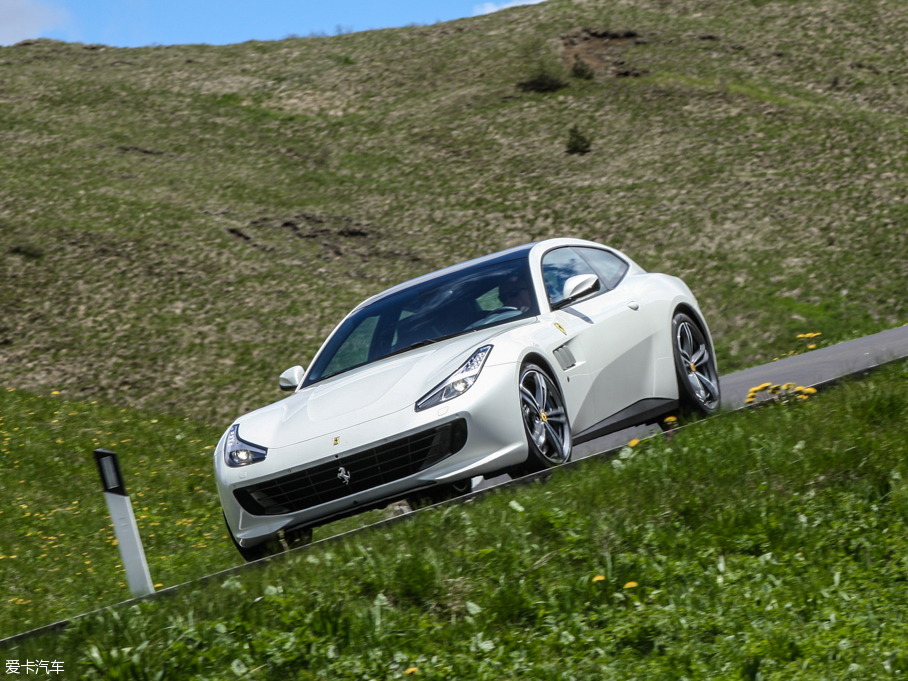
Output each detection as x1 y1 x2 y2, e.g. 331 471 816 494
95 449 154 597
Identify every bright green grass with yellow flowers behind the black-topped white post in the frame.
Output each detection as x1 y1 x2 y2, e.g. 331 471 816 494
0 389 385 638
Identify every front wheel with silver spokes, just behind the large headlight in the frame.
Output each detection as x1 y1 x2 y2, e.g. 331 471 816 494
517 364 572 473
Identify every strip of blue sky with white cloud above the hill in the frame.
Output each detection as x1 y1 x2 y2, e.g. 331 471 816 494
0 0 539 47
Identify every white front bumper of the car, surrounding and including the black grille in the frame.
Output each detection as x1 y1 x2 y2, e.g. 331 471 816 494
215 364 527 546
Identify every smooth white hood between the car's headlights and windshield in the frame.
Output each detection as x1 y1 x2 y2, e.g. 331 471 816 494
236 319 535 449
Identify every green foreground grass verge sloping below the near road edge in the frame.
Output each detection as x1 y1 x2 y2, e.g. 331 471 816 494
2 363 908 679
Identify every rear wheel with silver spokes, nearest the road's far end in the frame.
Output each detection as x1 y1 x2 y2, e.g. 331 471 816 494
672 312 721 416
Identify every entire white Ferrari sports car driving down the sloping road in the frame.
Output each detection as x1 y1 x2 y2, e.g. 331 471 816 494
214 239 719 560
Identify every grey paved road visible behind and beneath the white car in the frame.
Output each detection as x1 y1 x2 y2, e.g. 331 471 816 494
473 325 908 490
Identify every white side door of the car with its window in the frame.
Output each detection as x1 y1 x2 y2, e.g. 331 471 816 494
542 247 653 432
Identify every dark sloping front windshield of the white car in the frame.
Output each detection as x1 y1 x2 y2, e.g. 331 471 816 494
303 258 539 385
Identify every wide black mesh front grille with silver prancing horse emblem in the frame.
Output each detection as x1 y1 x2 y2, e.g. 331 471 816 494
233 419 467 515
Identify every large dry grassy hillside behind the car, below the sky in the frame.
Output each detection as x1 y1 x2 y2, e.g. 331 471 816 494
0 0 908 423
